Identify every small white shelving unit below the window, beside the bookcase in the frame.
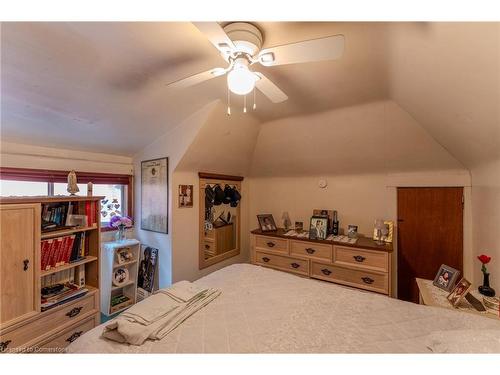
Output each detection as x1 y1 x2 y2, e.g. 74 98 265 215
101 239 141 316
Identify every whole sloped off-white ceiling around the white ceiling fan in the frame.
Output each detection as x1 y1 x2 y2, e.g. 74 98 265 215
1 22 500 174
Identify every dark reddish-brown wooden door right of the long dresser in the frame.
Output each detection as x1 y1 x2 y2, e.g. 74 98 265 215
398 187 463 303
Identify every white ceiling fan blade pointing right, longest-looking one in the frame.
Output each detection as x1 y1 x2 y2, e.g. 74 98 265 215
259 35 344 66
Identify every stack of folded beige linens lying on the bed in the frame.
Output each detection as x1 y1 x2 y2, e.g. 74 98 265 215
102 289 221 345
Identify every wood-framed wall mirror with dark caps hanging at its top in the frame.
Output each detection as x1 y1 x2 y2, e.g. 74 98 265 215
199 173 243 269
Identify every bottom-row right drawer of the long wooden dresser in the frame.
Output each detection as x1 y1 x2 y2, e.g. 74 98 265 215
311 262 389 294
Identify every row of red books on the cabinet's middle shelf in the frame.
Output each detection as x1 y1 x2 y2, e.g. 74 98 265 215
40 232 90 271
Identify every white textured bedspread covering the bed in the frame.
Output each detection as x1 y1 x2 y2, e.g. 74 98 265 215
68 264 500 353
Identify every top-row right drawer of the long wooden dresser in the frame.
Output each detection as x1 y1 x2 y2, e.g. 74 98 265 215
333 246 389 272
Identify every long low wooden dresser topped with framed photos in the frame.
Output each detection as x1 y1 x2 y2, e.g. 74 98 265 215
251 229 392 296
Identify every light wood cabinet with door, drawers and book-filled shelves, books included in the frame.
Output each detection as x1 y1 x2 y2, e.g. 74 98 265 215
0 196 104 352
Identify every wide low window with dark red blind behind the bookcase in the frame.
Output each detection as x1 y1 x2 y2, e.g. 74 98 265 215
0 168 133 228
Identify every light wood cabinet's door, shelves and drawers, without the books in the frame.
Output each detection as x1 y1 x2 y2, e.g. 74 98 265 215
0 196 103 353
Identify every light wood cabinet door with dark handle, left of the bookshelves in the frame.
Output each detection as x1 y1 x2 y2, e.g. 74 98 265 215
0 204 40 328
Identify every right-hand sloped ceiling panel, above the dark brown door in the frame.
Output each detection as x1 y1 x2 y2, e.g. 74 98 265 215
388 22 500 168
